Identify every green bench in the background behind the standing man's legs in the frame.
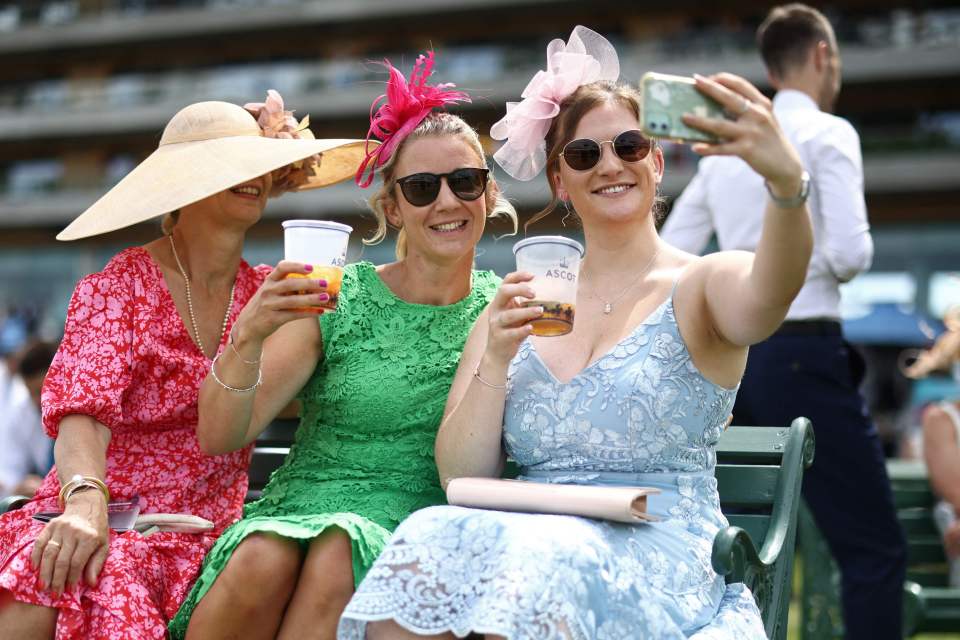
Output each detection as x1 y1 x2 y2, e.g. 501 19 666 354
799 460 960 640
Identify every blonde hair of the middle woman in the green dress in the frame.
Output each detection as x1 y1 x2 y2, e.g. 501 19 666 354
363 111 518 260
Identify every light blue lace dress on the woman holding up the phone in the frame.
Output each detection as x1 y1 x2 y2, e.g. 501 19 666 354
338 295 766 640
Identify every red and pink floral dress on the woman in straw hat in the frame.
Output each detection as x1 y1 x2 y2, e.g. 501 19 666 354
0 247 269 639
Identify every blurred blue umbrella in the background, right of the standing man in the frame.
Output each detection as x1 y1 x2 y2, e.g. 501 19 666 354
843 302 944 347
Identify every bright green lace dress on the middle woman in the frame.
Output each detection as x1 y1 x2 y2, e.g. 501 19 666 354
170 262 499 638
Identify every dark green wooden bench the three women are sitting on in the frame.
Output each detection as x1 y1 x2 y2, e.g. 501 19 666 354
3 418 813 640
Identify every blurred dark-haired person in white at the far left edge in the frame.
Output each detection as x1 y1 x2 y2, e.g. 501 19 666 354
0 342 56 498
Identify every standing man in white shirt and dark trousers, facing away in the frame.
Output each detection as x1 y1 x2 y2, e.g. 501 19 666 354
661 4 906 638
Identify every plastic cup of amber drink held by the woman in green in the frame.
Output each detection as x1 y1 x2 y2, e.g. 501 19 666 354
283 220 353 311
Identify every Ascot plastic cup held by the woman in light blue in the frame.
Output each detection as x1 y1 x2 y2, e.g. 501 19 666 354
513 236 583 336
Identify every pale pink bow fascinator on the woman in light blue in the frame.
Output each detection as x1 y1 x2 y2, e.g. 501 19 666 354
490 25 620 180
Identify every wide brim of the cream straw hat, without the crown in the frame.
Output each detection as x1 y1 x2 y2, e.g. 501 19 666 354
57 136 366 240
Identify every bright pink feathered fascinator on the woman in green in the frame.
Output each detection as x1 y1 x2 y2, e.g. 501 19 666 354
355 51 470 188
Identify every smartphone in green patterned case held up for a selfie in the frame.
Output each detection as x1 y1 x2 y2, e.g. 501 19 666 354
640 71 728 142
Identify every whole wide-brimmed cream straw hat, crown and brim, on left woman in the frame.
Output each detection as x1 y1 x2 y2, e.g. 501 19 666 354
57 102 365 240
